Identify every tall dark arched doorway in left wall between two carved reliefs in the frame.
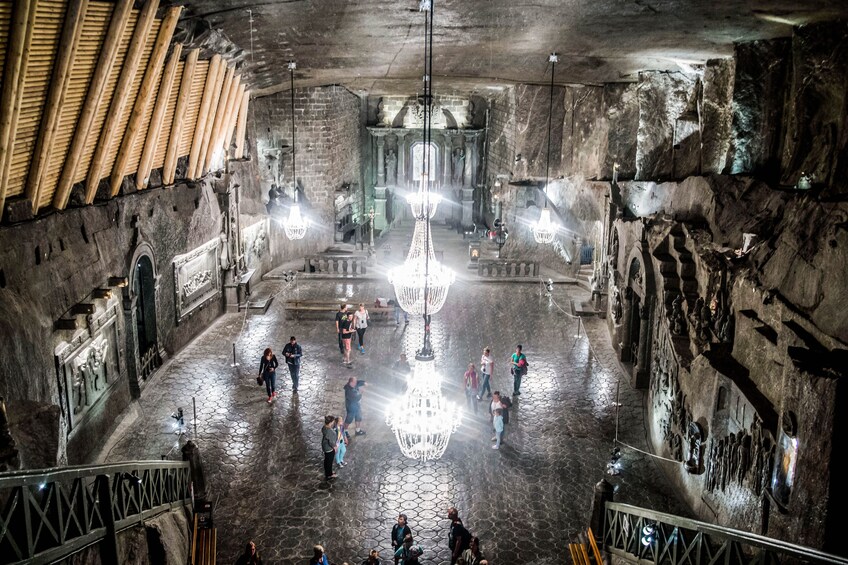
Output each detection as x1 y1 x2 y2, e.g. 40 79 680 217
123 242 164 398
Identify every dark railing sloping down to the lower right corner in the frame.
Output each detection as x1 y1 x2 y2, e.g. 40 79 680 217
603 502 848 565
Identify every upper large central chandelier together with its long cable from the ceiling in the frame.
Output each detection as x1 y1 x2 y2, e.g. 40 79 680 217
388 0 456 314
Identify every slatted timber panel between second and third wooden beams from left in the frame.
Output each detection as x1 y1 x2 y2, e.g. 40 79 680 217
38 2 114 208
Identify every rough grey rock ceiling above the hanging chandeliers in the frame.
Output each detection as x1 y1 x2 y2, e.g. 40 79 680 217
172 0 848 94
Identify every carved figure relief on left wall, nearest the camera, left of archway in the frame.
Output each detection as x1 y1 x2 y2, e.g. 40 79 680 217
56 306 120 429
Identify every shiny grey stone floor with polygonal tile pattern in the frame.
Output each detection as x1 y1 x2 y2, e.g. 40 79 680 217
105 220 688 565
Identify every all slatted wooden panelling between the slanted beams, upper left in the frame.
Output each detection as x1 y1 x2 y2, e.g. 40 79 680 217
0 0 252 216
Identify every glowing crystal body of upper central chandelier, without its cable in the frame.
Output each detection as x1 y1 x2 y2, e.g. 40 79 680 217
388 218 456 315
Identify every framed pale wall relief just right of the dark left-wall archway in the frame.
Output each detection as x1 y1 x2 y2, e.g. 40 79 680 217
174 238 221 322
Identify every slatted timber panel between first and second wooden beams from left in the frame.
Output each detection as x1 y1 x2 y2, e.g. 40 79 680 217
6 0 66 198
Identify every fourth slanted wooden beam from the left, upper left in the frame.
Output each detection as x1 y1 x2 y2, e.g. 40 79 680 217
85 0 159 204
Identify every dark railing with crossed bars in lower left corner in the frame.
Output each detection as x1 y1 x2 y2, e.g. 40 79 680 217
0 461 191 564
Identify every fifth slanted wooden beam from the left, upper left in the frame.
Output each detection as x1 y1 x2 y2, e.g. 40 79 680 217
109 6 183 197
